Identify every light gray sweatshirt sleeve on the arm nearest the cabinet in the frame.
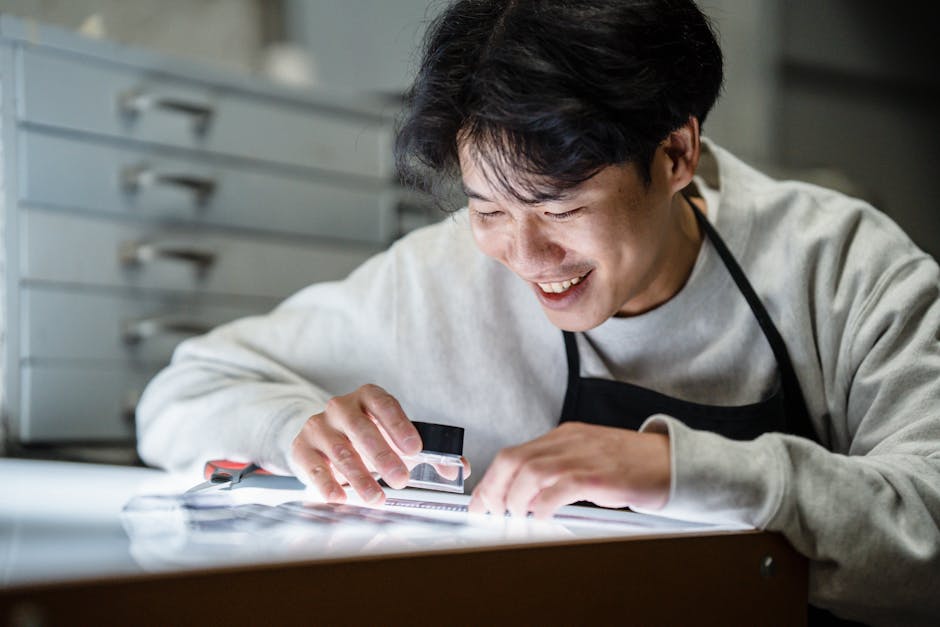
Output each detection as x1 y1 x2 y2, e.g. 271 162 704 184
137 248 397 473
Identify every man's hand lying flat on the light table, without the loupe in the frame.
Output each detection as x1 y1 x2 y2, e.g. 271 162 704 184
469 422 670 518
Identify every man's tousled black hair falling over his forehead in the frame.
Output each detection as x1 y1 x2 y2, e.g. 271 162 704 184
395 0 722 203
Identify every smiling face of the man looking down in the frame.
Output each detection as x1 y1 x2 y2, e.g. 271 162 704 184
460 146 681 331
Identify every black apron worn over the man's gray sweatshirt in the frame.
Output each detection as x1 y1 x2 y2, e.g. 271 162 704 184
560 200 859 626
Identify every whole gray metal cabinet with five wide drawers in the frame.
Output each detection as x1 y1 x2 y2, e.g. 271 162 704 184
0 17 430 454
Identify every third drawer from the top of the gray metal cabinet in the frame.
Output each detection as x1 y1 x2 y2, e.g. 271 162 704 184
20 209 376 298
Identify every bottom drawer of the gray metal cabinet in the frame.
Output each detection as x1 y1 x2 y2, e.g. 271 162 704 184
20 367 159 443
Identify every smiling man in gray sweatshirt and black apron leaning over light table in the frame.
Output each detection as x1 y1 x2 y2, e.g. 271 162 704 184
138 0 940 624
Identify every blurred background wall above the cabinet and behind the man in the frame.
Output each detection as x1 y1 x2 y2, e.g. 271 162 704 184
0 0 940 257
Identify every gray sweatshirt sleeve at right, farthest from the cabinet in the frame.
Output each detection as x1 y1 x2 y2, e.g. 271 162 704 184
643 256 940 625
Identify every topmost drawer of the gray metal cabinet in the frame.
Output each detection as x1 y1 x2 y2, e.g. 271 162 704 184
18 48 392 179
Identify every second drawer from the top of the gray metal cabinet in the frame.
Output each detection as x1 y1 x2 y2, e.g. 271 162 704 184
20 131 396 243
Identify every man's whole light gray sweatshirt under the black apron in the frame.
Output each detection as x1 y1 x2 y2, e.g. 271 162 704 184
138 143 940 625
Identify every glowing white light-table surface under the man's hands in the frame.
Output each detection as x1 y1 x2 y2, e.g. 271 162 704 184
0 459 744 587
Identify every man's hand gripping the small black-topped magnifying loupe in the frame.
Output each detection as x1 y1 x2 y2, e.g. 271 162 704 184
291 385 421 504
